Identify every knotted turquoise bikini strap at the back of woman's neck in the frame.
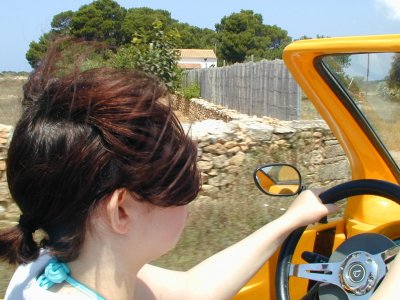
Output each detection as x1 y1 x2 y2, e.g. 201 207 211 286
36 258 105 300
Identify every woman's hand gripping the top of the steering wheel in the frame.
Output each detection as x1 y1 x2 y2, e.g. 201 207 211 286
284 189 338 227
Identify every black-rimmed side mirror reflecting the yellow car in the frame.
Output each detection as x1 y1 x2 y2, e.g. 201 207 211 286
254 164 302 196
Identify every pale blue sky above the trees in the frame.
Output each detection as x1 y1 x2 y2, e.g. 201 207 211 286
0 0 400 71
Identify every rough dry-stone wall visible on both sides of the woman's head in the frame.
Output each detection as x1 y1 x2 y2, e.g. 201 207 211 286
0 99 350 222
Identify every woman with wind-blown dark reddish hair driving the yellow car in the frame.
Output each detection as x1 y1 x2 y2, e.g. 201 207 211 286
0 40 336 300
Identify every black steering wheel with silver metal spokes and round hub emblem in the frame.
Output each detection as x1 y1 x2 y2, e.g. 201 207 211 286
276 179 400 300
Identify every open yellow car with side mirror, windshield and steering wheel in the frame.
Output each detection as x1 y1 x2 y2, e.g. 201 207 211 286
234 35 400 299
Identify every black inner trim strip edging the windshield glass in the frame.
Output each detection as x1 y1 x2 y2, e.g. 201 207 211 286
314 51 400 182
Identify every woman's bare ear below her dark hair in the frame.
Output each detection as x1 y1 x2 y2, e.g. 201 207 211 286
106 189 130 234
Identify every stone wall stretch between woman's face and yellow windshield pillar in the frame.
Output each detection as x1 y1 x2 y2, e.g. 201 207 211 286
188 118 350 197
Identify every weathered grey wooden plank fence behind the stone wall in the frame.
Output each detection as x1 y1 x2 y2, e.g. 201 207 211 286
183 60 301 120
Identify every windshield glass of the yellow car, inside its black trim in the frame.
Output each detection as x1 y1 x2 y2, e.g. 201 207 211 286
322 53 400 170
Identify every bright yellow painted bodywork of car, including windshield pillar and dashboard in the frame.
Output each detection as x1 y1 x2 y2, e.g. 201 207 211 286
234 35 400 300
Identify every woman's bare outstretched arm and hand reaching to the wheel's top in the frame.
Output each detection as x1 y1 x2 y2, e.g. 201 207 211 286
139 191 337 299
